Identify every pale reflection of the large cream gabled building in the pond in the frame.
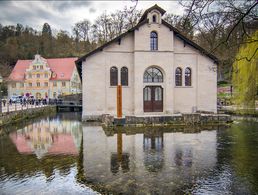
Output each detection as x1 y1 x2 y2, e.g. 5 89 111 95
83 126 217 194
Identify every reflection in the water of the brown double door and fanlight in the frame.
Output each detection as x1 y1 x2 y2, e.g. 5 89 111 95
143 131 164 172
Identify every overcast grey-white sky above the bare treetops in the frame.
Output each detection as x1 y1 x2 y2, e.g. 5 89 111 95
0 0 183 32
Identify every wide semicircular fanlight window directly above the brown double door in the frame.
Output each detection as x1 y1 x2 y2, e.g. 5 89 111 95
143 67 163 83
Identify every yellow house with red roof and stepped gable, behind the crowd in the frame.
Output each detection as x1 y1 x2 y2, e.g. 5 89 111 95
8 55 81 98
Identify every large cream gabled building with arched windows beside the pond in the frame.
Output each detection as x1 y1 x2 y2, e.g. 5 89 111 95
77 5 218 120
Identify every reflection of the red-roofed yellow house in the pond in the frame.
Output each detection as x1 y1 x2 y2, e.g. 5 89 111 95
9 118 82 159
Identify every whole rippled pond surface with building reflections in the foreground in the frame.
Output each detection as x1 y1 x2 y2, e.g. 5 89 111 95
0 113 258 195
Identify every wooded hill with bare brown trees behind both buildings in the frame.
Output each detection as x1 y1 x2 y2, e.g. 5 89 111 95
0 0 258 80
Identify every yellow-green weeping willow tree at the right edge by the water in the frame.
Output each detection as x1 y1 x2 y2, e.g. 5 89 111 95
232 30 258 113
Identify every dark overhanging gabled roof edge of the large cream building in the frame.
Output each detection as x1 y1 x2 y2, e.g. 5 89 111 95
76 4 219 65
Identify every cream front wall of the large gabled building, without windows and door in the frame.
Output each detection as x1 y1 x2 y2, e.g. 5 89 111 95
82 11 217 118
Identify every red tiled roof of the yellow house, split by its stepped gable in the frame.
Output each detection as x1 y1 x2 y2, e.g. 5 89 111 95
9 58 78 81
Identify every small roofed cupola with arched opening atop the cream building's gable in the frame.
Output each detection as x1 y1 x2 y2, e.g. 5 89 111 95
139 4 166 24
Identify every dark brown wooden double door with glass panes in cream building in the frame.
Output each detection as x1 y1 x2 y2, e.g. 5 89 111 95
143 86 163 112
